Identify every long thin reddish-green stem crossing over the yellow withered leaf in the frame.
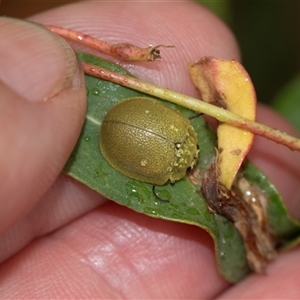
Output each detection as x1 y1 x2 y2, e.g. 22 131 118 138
82 63 300 151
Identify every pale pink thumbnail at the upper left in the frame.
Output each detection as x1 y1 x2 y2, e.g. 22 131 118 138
0 18 80 101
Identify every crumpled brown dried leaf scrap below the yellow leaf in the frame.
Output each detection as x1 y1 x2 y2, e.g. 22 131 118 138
201 163 276 274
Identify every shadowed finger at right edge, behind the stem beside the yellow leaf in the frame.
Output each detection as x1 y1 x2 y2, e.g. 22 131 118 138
249 105 300 219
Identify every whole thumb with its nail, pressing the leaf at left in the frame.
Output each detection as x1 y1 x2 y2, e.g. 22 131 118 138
0 18 86 234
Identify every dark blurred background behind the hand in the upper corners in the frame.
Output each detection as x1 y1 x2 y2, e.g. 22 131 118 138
0 0 300 114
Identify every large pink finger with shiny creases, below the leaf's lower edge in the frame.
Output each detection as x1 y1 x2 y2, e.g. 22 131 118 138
0 203 226 299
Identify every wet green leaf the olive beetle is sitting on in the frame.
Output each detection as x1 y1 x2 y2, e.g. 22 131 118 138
64 53 299 282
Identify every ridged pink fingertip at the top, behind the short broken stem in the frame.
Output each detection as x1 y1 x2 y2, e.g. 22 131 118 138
31 1 239 96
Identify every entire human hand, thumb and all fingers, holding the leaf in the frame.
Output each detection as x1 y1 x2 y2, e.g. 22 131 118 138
0 1 300 299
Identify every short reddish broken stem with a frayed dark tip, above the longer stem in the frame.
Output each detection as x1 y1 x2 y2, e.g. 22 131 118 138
46 25 174 62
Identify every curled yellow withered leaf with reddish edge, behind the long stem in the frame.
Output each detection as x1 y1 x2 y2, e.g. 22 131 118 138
189 57 256 189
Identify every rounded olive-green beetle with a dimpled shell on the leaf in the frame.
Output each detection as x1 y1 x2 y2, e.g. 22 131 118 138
100 97 199 185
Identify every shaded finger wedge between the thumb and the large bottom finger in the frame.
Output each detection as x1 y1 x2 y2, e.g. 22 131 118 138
0 174 106 263
